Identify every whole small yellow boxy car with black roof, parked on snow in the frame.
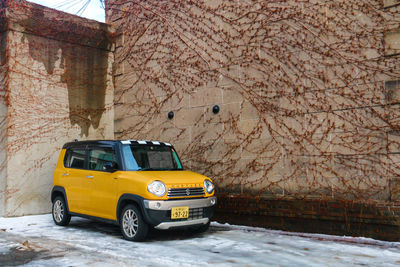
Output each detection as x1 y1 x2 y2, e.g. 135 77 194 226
51 140 217 241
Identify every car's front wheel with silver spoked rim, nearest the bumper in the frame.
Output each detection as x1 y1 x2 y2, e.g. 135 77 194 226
119 204 149 241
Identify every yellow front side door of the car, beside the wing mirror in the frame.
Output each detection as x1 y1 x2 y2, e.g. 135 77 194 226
89 146 118 220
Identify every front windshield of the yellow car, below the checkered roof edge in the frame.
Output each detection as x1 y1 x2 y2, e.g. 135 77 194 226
122 145 183 171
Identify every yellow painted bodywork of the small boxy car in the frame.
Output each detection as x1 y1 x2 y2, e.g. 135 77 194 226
53 141 214 231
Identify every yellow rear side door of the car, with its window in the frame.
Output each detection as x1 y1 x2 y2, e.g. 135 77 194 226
62 147 92 214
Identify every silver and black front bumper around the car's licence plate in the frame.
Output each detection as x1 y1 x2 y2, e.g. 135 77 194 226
143 197 217 229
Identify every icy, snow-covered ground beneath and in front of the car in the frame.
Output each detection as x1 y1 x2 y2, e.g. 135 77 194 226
0 215 400 266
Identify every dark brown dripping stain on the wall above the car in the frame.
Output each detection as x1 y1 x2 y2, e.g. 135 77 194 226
22 9 109 136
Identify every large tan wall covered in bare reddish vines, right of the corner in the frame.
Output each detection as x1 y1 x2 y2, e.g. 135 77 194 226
107 0 400 238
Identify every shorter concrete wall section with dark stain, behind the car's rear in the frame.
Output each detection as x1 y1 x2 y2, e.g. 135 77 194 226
0 1 114 216
